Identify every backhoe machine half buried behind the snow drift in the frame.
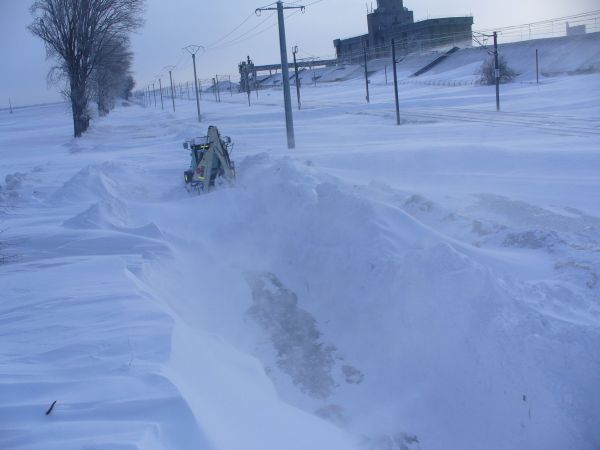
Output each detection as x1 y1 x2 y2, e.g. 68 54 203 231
183 126 235 192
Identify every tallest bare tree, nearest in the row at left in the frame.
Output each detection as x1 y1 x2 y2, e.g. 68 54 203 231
29 0 144 137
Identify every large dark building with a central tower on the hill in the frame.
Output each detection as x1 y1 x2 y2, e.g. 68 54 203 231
333 0 473 62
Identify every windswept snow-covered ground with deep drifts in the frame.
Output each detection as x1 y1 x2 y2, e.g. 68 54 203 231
0 39 600 450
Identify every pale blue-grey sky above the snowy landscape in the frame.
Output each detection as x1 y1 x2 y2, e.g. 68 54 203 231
0 0 600 107
